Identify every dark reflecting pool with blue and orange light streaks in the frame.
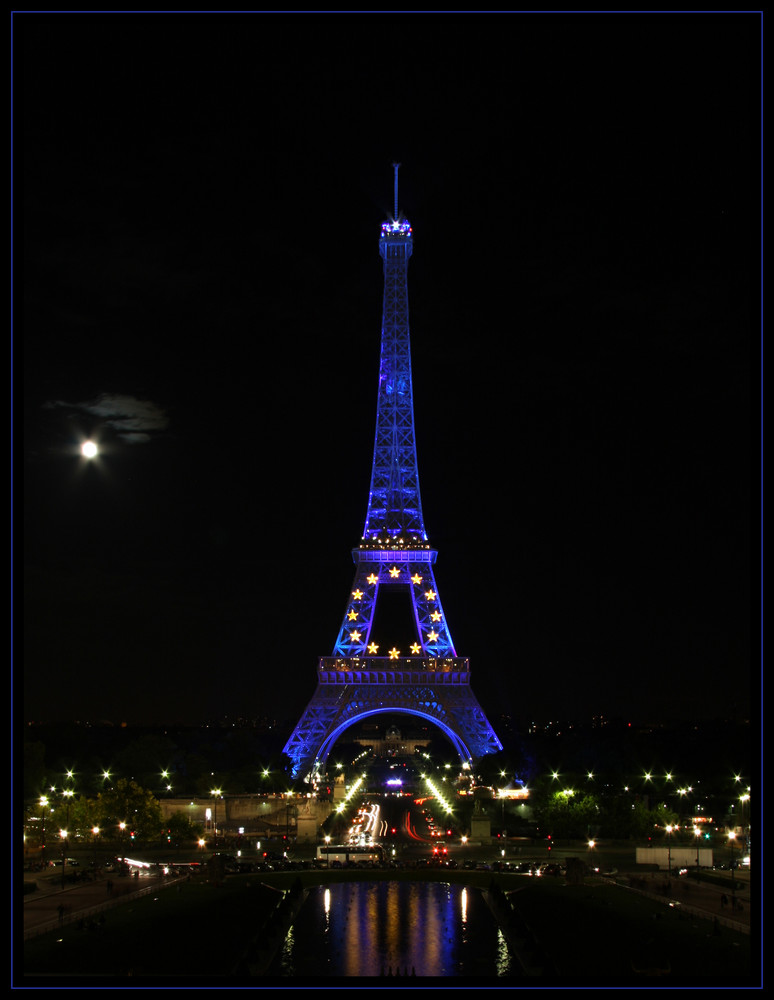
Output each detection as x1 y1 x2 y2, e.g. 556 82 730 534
269 882 518 978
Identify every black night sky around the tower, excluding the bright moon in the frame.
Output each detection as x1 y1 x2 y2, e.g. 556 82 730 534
18 13 760 735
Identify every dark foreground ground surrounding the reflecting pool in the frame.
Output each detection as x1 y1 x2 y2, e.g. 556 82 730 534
19 870 761 988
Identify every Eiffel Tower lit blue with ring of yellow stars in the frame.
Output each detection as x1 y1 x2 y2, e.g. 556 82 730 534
284 164 502 778
